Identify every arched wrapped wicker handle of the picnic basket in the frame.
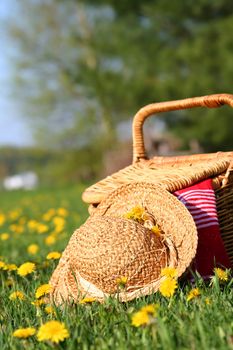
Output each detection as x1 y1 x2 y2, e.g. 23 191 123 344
133 94 233 163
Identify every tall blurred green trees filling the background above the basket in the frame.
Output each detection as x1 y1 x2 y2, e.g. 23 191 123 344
6 0 233 183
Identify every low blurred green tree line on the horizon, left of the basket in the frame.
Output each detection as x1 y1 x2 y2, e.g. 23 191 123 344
0 147 101 189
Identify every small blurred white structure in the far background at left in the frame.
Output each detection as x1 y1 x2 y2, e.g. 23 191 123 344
3 171 38 191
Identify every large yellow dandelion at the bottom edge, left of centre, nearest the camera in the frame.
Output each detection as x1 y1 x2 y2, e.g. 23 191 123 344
37 321 69 343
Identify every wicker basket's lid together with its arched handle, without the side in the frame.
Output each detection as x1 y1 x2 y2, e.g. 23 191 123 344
82 94 233 204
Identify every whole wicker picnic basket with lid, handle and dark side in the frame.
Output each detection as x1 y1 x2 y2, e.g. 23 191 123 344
82 94 233 265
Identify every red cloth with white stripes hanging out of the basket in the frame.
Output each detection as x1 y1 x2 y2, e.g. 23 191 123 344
174 179 231 277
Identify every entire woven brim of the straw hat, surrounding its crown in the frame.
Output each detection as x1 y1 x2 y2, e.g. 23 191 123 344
51 182 198 301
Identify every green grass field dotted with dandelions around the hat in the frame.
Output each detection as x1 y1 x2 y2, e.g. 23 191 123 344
0 186 233 350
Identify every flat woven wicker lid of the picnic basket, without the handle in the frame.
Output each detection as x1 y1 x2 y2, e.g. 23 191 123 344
82 157 232 204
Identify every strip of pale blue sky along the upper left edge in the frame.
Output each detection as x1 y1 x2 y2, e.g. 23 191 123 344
0 0 33 146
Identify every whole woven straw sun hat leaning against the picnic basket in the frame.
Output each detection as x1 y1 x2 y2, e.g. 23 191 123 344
50 183 197 304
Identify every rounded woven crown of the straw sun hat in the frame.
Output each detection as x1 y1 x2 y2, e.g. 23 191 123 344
70 216 168 293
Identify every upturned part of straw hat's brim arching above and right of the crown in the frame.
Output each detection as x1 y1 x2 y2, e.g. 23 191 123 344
94 182 197 276
